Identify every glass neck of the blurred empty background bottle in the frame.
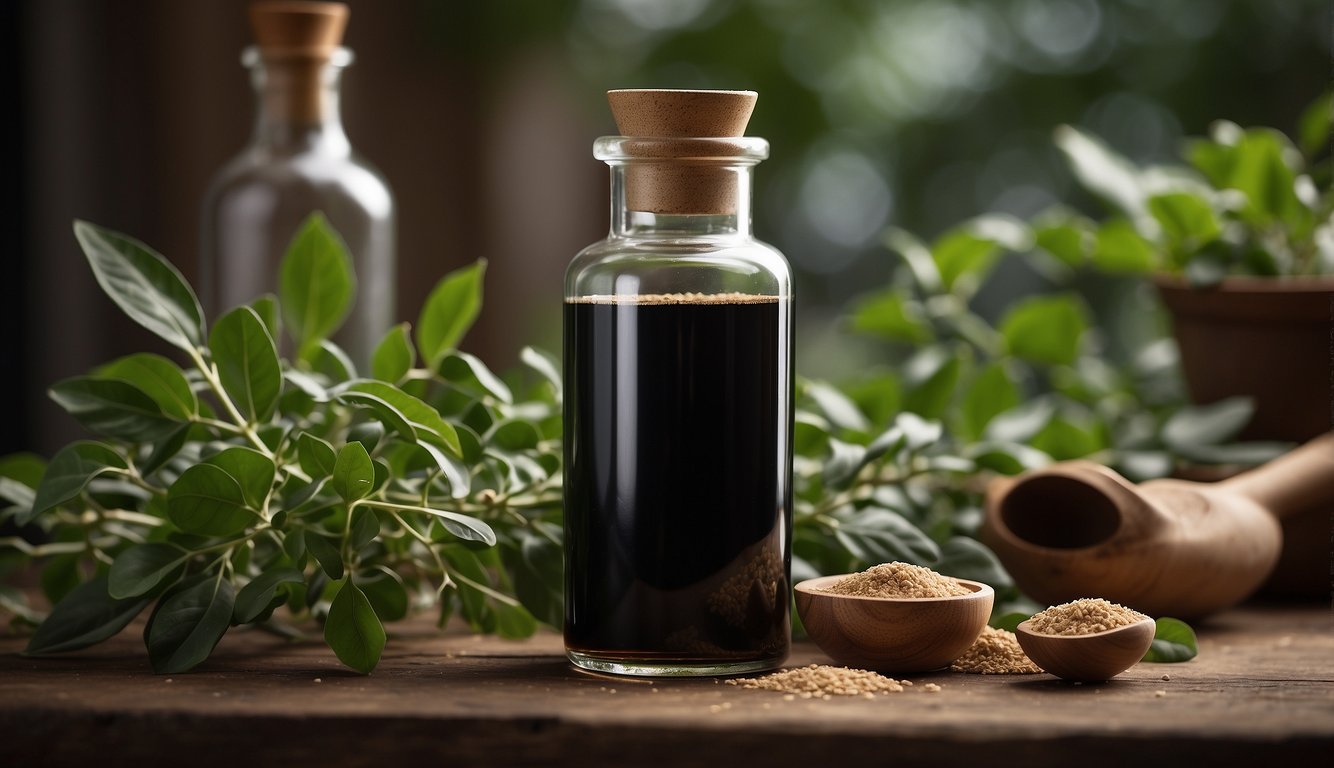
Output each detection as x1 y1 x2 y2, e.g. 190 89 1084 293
243 48 352 155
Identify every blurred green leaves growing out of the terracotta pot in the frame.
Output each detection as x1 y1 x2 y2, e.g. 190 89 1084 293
1047 93 1334 285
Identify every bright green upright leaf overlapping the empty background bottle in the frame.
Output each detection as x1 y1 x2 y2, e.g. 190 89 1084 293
277 212 356 359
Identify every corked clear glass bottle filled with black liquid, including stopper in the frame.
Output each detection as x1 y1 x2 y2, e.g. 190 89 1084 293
564 91 792 675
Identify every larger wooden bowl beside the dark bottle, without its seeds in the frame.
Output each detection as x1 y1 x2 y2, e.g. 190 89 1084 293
795 575 995 672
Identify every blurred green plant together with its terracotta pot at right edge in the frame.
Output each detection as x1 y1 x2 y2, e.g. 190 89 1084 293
1057 95 1334 596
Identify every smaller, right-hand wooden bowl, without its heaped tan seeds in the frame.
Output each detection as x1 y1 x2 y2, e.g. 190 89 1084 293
1014 619 1157 683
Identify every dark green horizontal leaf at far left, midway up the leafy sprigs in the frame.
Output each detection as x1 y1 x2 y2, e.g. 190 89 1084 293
49 376 179 443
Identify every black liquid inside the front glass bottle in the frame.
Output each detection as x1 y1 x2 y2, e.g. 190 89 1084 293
564 293 792 665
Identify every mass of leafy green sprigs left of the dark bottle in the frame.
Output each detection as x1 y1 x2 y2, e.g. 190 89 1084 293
0 215 562 673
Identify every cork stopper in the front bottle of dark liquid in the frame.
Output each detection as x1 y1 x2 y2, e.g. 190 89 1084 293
607 89 759 215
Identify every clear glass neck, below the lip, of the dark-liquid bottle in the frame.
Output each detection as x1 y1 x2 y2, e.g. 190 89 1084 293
611 161 752 239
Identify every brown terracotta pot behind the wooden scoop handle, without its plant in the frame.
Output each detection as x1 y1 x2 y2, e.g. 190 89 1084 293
1154 276 1334 599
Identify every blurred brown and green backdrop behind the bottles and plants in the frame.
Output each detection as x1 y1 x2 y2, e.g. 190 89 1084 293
0 0 1334 452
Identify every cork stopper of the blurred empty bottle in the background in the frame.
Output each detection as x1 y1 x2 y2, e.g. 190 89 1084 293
249 0 348 124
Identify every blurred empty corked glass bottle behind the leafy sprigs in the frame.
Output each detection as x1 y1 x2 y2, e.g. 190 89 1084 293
200 3 395 365
